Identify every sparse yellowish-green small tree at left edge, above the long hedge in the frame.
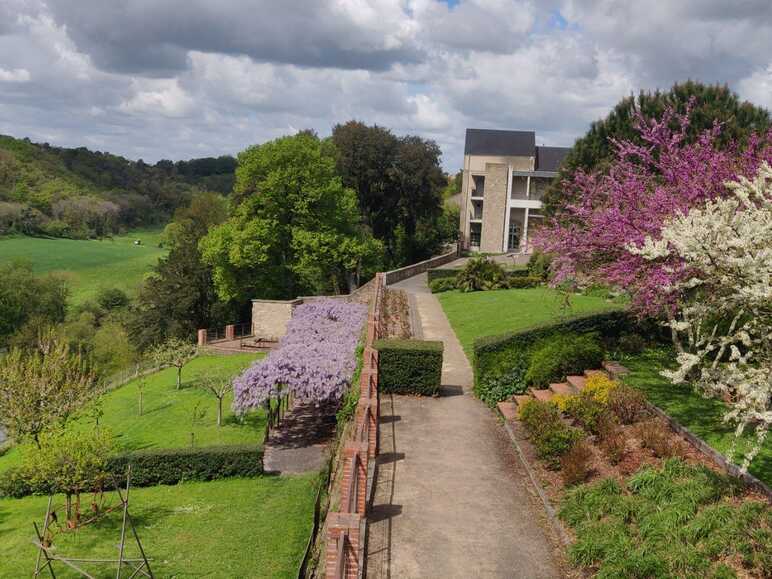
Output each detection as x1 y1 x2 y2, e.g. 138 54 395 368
0 331 98 448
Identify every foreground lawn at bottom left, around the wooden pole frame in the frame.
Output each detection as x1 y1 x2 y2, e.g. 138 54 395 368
0 475 316 578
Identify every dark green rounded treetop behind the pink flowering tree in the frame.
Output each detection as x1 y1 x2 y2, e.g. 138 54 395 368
544 81 772 216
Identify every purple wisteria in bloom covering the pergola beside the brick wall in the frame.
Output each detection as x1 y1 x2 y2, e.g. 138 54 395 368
233 299 367 413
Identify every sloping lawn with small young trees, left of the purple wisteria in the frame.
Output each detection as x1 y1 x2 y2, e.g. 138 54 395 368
0 353 265 471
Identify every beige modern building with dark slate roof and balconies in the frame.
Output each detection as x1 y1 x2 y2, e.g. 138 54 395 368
460 129 569 253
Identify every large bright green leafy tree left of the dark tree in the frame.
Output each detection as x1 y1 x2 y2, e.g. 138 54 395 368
200 132 381 300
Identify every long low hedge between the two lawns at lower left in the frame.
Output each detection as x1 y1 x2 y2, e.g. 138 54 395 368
0 445 263 498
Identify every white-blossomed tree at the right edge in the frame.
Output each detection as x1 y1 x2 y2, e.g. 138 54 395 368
628 163 772 470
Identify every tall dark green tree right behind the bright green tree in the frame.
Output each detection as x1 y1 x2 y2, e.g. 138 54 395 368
332 121 447 266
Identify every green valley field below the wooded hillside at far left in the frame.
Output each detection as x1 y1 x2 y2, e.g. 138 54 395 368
0 229 166 304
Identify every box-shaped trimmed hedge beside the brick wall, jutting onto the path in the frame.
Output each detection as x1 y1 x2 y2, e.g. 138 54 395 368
373 339 443 396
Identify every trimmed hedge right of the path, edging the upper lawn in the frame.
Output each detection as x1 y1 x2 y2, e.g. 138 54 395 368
473 310 636 406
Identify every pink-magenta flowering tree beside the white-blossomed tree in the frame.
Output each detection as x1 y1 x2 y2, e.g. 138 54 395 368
534 105 772 318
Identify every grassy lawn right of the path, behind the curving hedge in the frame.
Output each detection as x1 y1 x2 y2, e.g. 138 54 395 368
437 287 620 356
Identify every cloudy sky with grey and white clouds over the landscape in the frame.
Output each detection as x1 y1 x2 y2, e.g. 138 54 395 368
0 0 772 170
